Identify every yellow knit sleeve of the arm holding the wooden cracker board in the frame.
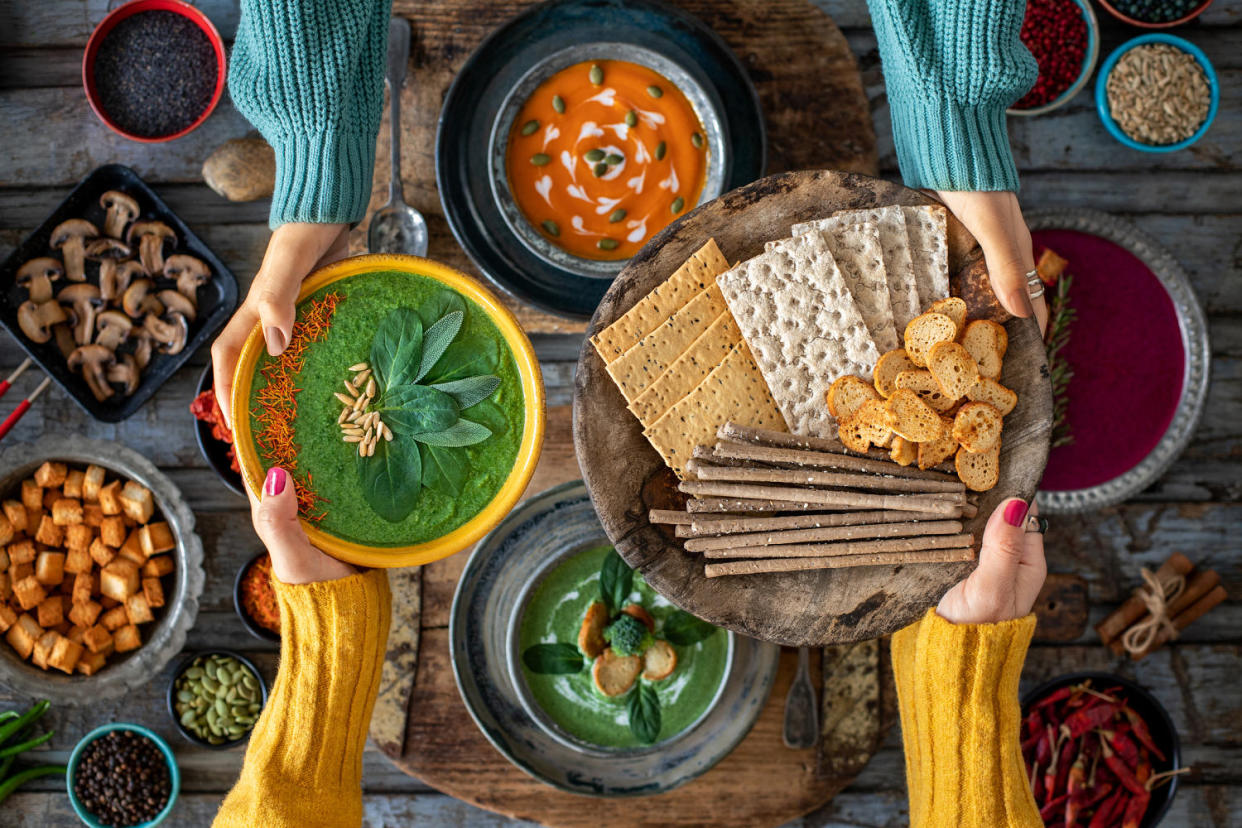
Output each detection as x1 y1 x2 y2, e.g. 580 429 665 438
892 610 1043 828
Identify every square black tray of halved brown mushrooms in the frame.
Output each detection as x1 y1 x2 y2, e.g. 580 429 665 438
0 164 237 422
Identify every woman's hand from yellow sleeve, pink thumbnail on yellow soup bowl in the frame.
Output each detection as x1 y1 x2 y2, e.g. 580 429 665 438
250 466 356 583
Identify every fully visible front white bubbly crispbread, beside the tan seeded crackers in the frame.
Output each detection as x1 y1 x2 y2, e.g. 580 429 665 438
717 233 879 438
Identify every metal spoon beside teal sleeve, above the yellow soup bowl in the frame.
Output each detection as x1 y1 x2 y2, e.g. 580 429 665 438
366 17 427 256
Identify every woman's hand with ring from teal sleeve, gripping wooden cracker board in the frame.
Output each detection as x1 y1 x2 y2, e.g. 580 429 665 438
936 190 1048 333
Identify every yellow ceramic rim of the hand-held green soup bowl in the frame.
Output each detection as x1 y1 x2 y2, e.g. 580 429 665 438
230 256 545 567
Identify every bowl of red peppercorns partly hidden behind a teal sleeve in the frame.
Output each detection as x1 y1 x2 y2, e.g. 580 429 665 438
1009 0 1099 115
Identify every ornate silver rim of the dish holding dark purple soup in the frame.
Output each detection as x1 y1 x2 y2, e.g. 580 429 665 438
1026 209 1211 514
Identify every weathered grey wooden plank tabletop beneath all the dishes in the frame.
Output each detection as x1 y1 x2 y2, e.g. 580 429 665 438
0 0 1242 828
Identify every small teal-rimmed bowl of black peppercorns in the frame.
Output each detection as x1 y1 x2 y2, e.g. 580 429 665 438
65 721 181 828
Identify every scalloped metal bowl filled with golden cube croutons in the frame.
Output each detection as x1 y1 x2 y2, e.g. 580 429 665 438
0 434 205 704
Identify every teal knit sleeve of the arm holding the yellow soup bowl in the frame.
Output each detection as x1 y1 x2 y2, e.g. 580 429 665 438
229 0 391 228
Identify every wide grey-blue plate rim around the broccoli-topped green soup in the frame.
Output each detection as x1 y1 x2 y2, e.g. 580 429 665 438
450 480 780 797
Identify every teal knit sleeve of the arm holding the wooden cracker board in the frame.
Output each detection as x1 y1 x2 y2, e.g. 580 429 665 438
868 0 1038 190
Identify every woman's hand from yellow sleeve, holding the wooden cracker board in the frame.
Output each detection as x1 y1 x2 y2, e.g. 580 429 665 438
936 498 1048 624
